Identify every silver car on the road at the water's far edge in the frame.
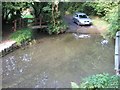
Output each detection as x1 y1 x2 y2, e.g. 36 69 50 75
72 12 92 26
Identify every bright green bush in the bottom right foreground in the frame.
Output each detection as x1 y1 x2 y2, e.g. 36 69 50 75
71 74 119 90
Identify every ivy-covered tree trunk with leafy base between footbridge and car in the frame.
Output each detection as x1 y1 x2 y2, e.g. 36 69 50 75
43 2 67 34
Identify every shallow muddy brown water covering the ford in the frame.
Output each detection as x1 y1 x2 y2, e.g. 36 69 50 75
2 34 114 88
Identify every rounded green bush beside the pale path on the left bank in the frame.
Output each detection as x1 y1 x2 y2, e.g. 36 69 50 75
10 29 32 45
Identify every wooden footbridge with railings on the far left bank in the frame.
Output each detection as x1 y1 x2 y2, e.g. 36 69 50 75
12 17 47 31
